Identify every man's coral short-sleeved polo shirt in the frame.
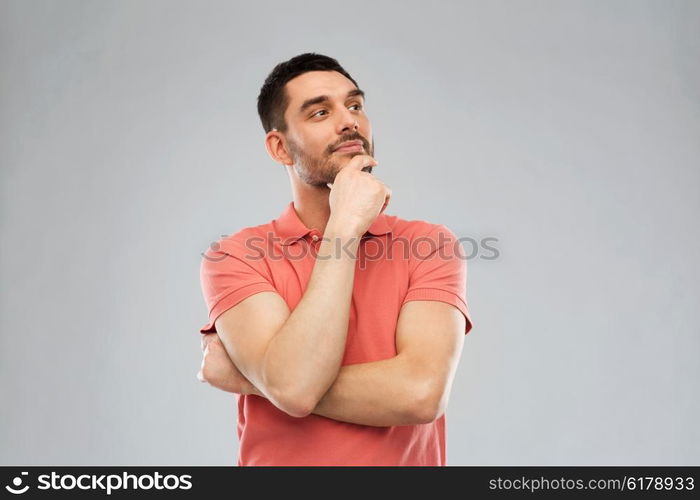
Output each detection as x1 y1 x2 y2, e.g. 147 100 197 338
200 202 472 466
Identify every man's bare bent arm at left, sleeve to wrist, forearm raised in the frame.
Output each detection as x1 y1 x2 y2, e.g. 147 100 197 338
215 216 359 417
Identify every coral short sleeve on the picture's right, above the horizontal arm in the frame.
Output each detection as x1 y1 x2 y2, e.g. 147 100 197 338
402 224 473 335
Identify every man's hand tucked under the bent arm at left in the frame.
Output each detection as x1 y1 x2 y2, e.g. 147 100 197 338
197 333 262 396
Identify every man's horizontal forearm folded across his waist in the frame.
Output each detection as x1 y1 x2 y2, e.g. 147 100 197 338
312 356 431 426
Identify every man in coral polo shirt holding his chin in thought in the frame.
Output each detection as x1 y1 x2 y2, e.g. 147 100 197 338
198 53 472 465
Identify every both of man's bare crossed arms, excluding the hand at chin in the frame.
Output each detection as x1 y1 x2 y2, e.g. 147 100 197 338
200 225 466 426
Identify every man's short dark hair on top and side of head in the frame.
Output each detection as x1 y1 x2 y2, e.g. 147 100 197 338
258 52 358 133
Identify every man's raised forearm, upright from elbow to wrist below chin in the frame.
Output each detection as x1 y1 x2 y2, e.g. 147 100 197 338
263 217 359 411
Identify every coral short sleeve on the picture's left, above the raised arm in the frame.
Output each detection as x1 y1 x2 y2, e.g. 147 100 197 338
199 233 277 333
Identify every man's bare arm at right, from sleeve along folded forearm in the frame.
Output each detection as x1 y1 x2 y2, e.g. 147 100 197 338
313 300 466 426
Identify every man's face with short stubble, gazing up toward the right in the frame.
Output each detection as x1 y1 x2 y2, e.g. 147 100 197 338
284 71 374 187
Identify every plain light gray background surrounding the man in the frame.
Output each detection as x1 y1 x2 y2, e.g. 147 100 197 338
0 0 700 465
